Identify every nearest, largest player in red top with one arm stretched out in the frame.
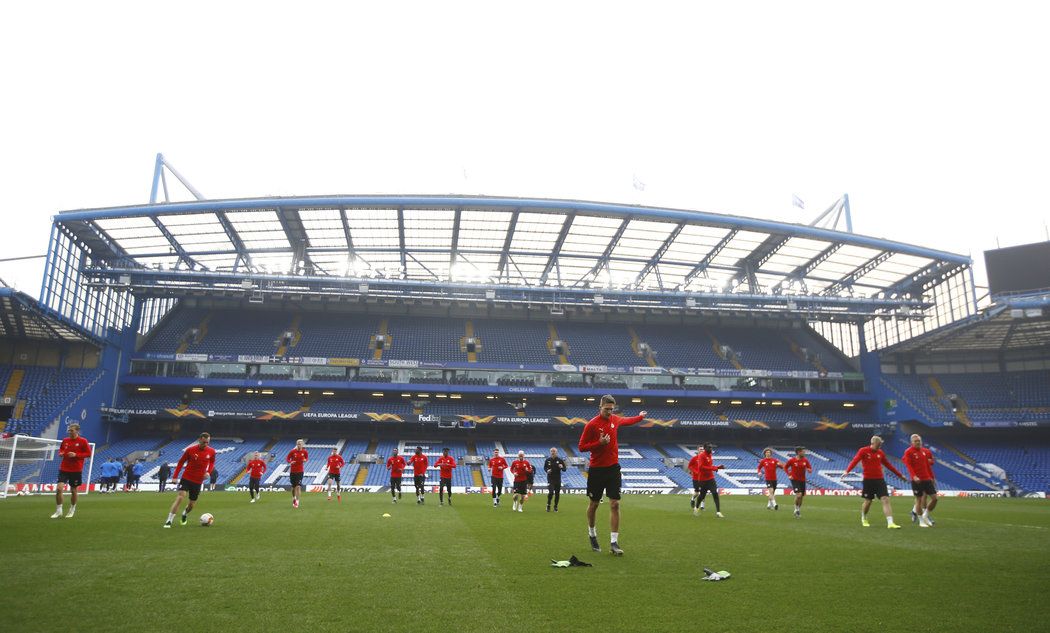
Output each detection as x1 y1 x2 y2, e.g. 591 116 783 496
578 396 646 556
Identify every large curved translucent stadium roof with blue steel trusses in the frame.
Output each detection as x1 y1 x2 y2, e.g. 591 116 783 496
55 195 971 321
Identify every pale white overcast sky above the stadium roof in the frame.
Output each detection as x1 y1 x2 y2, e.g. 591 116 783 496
0 1 1050 296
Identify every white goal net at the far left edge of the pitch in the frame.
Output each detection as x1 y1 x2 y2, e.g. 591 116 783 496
0 436 95 499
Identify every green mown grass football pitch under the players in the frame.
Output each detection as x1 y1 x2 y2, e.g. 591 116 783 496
0 492 1050 633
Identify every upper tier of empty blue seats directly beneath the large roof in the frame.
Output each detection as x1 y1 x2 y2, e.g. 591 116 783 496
135 310 851 372
